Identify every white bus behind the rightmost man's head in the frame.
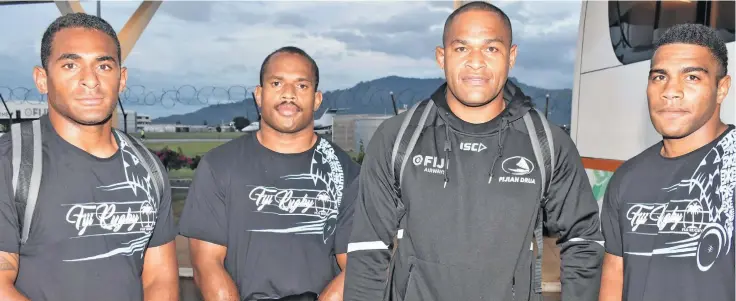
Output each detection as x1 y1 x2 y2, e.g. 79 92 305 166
570 0 736 204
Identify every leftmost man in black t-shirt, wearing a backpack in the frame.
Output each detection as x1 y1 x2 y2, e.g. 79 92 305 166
0 13 179 301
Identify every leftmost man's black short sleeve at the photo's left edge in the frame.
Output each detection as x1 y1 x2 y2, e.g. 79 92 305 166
0 138 20 254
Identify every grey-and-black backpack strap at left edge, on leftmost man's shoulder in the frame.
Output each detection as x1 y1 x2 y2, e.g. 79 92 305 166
10 120 43 245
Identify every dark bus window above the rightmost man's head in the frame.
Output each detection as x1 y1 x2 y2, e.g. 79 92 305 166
608 0 734 65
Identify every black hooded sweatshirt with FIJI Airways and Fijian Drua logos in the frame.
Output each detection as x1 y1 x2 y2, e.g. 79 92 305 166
343 84 604 301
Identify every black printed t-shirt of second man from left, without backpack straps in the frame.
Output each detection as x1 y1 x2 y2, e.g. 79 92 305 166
179 135 360 300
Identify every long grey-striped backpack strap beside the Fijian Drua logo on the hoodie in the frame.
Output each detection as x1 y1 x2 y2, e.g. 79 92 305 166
524 109 555 294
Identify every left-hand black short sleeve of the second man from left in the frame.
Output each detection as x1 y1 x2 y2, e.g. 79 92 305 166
179 155 227 246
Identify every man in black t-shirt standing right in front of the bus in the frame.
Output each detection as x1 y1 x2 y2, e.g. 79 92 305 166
600 24 736 301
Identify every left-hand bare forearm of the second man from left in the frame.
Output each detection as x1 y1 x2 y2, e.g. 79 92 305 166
189 238 240 301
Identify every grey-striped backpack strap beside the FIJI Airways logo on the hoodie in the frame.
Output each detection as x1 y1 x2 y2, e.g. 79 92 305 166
391 99 434 193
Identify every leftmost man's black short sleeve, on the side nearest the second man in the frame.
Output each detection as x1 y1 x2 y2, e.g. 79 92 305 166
149 156 176 248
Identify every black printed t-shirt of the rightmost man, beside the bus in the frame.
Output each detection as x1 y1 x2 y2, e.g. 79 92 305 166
601 125 736 301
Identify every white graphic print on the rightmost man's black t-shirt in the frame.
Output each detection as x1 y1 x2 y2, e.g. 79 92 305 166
626 131 736 271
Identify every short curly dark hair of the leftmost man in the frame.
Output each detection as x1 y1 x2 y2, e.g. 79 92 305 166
41 13 121 69
